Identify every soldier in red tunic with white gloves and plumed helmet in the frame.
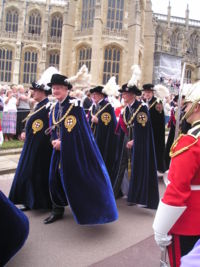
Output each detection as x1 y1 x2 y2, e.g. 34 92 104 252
153 82 200 267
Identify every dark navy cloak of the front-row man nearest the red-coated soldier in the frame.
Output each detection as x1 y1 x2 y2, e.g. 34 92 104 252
115 100 159 209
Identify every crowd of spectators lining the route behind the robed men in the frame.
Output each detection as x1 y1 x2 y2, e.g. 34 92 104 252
0 82 180 141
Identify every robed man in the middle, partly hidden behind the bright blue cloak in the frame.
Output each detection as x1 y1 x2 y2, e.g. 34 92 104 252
89 86 118 184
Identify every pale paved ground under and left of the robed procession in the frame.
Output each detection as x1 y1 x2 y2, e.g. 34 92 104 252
0 154 167 267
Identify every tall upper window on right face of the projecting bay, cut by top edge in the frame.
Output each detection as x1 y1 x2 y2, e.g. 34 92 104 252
107 0 124 30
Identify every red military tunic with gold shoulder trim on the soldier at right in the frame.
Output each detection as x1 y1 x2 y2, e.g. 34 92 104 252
162 122 200 236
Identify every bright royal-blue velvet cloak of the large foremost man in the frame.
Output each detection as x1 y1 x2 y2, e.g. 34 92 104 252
50 97 118 225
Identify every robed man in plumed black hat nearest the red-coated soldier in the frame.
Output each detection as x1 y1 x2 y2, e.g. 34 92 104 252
114 84 159 209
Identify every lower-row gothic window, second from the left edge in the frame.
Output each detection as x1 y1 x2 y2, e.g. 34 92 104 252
23 51 38 83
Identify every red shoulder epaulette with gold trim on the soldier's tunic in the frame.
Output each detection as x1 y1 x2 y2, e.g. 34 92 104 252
169 134 198 158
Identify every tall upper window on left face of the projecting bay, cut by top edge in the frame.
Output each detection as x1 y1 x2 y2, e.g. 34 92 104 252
81 0 96 30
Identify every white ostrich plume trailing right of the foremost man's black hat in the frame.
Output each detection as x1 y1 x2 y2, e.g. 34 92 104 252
67 65 91 89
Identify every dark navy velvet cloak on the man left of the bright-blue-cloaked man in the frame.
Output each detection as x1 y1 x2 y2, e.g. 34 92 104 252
9 98 52 209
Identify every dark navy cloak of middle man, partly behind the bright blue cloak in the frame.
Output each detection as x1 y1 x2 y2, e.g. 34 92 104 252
89 99 118 184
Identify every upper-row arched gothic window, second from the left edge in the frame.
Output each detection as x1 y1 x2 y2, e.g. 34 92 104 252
28 11 42 35
